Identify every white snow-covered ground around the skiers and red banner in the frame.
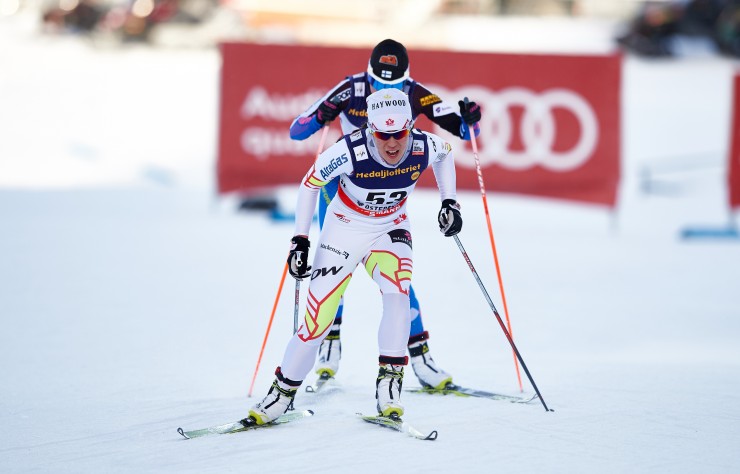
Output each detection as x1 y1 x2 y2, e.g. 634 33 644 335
0 11 740 473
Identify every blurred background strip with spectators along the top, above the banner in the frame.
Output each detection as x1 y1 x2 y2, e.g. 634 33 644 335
0 0 740 57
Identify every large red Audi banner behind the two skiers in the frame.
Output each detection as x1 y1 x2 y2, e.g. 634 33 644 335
218 43 621 207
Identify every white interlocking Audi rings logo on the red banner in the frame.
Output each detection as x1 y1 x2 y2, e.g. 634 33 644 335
430 86 599 172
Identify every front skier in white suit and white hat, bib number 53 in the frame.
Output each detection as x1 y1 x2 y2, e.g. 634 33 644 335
249 88 462 425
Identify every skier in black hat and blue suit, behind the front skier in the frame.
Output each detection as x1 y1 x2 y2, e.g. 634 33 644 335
290 39 481 388
